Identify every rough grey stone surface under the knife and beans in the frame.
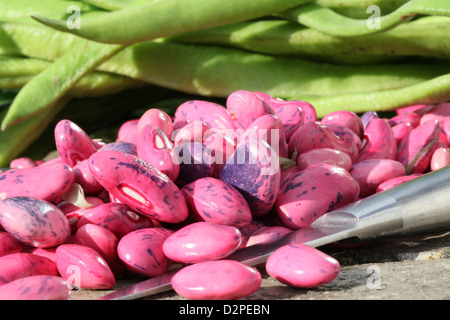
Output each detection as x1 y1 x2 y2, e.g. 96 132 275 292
71 230 450 300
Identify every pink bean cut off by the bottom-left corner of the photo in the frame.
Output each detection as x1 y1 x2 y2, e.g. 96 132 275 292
0 275 72 300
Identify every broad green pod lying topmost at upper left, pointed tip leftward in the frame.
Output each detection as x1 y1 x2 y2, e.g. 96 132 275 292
33 0 310 44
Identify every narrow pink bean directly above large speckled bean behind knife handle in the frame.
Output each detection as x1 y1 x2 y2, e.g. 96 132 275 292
297 148 352 171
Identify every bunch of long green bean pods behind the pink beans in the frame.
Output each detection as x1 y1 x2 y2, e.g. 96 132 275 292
0 0 450 166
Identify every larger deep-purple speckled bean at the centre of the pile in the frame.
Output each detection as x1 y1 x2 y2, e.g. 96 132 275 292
220 139 281 216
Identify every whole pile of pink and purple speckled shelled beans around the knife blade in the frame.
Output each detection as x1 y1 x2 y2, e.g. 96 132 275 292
0 90 450 299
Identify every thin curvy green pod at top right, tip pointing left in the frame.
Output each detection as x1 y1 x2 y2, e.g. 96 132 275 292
276 0 450 37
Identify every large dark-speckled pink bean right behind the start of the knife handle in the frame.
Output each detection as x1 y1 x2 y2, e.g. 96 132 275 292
275 164 359 229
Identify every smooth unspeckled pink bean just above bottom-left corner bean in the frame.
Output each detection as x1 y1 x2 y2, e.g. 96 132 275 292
55 244 116 290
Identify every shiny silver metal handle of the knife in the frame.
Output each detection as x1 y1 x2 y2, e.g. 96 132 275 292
338 166 450 241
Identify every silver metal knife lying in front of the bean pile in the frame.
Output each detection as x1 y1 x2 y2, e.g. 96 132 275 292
98 166 450 300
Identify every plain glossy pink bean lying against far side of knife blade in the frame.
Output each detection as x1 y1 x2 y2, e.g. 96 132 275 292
163 222 242 264
